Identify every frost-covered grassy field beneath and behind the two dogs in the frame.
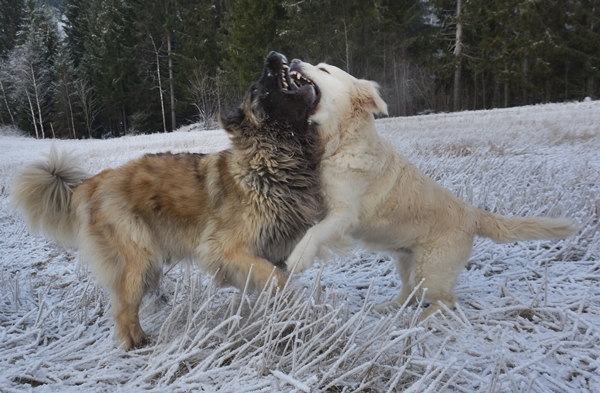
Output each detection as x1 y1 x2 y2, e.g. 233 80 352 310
0 101 600 392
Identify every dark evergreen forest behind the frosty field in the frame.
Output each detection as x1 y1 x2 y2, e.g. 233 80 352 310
0 0 600 138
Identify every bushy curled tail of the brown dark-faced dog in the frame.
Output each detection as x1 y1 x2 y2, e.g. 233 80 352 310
11 146 89 245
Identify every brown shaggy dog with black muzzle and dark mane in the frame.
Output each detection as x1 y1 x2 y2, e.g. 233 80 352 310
12 53 325 348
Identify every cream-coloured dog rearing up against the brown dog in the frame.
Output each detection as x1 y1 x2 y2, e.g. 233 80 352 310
287 60 576 318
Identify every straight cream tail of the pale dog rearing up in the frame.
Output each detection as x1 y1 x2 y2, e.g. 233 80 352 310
477 210 577 243
